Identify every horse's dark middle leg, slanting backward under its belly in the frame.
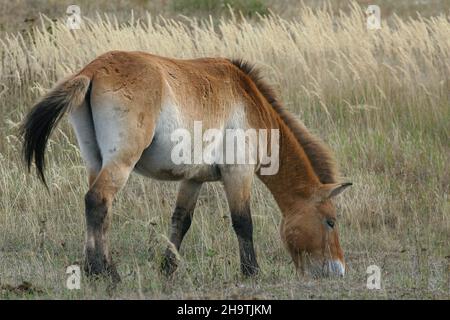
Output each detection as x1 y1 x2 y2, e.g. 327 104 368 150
161 180 202 276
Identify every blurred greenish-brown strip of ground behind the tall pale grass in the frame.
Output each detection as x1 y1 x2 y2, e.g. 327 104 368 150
0 0 450 34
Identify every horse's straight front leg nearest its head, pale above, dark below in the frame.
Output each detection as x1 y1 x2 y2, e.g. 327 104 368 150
220 165 259 276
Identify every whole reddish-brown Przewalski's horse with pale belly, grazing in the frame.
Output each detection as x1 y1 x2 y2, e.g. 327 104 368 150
22 51 350 280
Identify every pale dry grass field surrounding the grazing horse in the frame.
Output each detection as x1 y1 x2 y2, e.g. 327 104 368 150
0 2 450 299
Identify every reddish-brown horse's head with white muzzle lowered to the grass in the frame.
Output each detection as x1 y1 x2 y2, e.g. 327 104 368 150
281 183 351 276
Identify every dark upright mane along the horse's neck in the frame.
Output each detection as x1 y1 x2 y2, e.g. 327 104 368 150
231 59 338 183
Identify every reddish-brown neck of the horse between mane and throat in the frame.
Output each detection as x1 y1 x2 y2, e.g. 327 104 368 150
258 119 320 215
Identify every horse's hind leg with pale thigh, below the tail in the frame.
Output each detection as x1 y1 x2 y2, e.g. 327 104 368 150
85 90 154 281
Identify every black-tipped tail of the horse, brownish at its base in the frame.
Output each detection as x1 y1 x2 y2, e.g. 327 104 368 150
20 75 91 188
